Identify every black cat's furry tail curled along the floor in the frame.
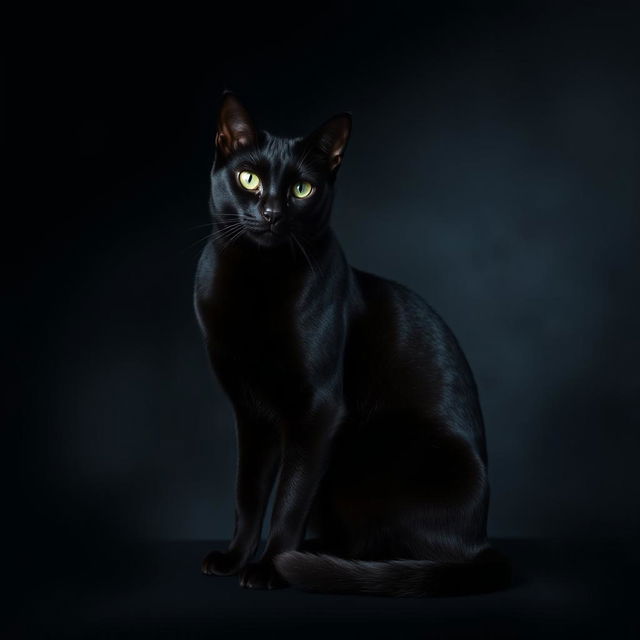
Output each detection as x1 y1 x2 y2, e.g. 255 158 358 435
274 548 511 597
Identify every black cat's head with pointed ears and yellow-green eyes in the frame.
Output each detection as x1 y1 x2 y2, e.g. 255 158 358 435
211 93 351 247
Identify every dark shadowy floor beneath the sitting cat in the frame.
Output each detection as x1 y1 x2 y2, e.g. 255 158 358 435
22 540 638 640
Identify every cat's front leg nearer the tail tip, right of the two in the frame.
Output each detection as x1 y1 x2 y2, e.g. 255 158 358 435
240 408 342 589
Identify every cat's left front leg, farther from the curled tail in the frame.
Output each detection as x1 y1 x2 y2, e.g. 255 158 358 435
202 418 280 576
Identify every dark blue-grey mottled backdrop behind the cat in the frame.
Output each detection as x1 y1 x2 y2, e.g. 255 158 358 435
4 1 640 636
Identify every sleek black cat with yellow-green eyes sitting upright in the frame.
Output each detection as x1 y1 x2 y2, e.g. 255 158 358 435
195 93 510 596
